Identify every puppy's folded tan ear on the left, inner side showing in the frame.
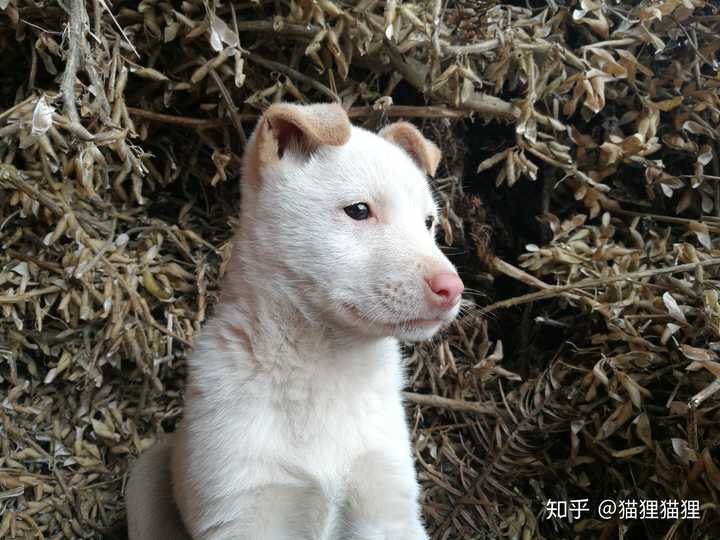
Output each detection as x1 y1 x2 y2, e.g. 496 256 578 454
255 103 350 166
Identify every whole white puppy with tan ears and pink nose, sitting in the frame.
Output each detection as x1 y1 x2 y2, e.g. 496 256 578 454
127 104 463 540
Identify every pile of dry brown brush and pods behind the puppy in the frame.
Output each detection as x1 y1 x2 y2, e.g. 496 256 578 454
0 0 720 540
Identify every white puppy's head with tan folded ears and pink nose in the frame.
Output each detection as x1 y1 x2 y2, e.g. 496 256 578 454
239 104 463 340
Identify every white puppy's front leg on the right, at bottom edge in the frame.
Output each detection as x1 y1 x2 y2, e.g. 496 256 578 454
338 452 429 540
